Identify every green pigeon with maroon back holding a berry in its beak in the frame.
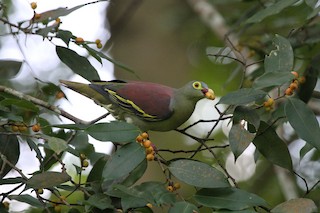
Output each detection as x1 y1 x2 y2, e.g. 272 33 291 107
60 80 215 132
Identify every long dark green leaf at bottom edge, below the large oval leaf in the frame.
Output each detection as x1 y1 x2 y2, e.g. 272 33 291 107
194 188 268 211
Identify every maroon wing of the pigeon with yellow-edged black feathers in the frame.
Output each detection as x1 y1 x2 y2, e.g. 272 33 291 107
90 80 174 121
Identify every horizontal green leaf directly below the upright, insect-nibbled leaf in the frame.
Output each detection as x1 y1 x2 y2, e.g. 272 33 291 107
253 72 294 89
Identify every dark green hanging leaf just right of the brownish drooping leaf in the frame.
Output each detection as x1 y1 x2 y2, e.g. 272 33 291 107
253 122 292 171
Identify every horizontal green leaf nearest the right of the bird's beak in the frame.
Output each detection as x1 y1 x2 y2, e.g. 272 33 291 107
219 88 267 105
